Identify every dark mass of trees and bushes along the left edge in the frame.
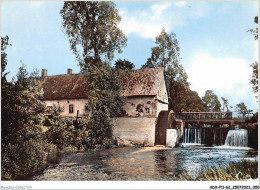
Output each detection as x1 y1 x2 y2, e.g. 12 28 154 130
1 36 55 180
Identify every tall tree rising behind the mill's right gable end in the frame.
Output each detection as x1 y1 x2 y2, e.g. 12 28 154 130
141 28 193 112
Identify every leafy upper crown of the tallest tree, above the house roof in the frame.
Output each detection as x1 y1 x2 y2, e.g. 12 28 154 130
60 1 127 72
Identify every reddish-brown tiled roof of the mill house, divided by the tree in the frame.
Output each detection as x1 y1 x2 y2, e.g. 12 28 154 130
41 68 164 100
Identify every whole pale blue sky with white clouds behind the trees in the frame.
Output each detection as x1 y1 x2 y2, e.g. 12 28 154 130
1 1 259 111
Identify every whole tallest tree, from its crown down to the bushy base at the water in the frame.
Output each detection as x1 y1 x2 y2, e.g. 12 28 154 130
60 1 126 148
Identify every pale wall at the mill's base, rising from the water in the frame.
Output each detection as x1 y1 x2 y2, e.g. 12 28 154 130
112 117 157 146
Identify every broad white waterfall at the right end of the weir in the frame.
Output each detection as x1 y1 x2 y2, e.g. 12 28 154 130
225 129 248 147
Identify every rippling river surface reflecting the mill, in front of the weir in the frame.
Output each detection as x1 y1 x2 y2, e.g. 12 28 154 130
32 146 258 180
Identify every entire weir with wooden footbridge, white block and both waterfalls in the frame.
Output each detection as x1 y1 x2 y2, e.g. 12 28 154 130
165 111 252 147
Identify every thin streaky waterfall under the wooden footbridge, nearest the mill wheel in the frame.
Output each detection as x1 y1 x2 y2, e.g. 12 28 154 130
183 128 201 144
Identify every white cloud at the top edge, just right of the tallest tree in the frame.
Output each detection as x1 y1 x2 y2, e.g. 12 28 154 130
119 1 209 39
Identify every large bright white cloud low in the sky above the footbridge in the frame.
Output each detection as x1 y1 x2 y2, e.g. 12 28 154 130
187 53 251 97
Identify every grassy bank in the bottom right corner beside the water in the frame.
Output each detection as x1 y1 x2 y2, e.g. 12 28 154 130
177 160 258 181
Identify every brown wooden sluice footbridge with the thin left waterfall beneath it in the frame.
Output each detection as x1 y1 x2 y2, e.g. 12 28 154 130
176 112 248 146
